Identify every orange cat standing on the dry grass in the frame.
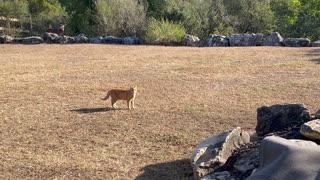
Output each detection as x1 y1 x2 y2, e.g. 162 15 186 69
101 86 137 109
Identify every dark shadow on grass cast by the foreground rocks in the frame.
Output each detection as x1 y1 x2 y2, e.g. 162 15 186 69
135 159 194 180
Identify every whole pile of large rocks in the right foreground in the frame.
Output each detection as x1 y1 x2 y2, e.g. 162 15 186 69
191 104 320 180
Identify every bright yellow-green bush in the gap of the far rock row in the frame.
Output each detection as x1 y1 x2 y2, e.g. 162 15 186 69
145 18 186 45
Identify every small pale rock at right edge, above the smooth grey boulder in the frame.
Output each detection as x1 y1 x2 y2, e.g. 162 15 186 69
300 119 320 140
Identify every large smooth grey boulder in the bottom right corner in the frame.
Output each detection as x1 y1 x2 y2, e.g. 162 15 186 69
247 136 320 180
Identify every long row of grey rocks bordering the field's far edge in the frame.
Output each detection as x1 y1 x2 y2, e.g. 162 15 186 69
0 31 320 47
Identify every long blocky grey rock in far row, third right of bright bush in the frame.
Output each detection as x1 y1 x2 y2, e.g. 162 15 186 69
229 33 263 46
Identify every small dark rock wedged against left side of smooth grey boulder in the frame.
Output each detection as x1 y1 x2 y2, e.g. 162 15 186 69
233 149 259 173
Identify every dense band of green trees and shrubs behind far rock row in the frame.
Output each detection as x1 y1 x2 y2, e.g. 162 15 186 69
0 0 320 40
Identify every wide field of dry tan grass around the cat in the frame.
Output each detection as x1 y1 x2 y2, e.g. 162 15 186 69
0 45 320 180
